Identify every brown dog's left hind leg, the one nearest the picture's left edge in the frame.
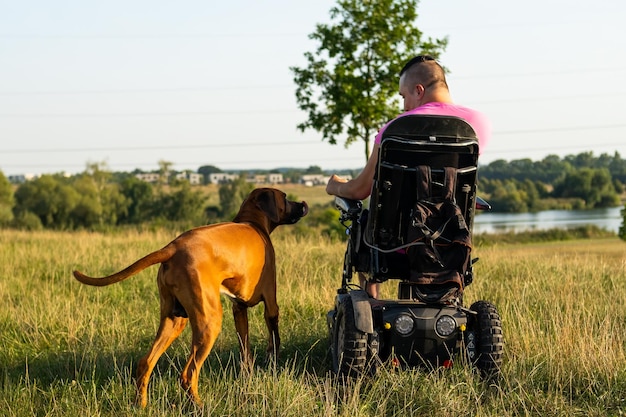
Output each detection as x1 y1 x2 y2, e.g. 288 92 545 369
136 312 188 407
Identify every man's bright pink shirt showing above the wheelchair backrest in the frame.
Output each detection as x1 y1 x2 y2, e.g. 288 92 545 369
374 102 491 153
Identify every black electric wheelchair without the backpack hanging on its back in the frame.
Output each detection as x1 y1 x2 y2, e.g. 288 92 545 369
327 115 504 378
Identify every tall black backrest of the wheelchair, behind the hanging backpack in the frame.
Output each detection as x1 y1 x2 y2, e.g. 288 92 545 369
365 115 479 252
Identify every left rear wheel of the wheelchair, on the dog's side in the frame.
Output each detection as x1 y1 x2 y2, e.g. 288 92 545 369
331 297 367 377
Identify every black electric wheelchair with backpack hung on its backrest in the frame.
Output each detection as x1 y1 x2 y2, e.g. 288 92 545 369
327 115 504 379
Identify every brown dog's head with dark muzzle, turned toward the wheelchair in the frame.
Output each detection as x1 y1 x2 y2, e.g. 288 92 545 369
233 188 309 232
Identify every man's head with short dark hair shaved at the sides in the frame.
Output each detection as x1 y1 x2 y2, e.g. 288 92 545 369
400 55 451 111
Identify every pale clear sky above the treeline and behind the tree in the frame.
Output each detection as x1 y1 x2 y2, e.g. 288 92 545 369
0 0 626 176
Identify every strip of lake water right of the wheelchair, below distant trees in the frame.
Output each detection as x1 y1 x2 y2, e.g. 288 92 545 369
474 206 623 233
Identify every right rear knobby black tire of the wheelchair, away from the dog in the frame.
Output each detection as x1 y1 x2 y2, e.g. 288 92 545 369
466 301 504 380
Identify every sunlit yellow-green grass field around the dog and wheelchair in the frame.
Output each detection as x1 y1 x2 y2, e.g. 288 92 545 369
0 228 626 417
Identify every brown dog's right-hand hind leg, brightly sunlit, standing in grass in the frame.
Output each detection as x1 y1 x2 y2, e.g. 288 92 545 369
180 300 222 404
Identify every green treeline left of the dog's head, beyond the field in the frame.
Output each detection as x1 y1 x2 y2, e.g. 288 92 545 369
0 165 254 230
